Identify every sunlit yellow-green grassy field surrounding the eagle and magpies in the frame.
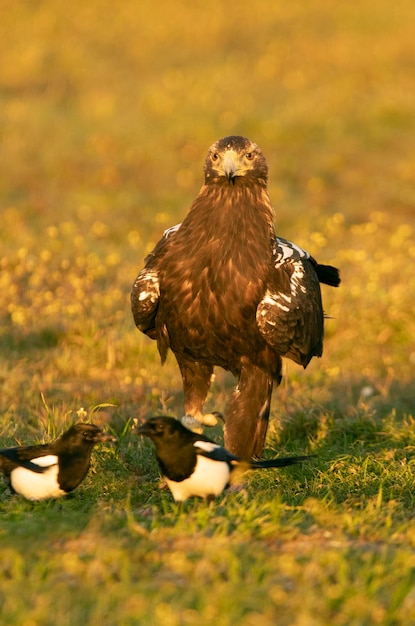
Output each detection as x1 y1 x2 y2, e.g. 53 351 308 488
0 0 415 626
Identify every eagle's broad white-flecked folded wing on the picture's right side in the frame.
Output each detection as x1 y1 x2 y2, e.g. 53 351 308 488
256 238 324 367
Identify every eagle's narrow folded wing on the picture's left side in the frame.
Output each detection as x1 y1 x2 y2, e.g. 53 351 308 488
131 224 180 339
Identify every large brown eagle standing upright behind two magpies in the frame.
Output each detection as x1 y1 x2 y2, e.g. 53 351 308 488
131 136 340 459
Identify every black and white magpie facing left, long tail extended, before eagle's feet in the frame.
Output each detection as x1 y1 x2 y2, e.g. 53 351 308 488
135 416 311 502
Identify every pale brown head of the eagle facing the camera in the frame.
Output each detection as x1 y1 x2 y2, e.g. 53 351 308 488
203 135 268 186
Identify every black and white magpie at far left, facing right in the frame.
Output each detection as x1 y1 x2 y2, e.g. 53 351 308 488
0 423 116 500
